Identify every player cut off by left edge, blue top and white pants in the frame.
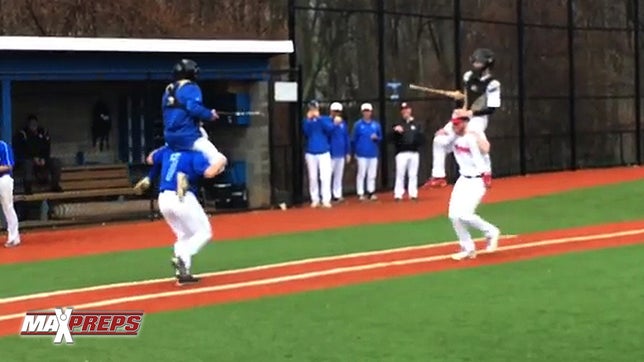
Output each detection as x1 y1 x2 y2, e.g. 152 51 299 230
0 141 20 248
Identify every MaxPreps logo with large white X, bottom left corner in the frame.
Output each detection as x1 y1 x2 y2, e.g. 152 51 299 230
20 308 143 344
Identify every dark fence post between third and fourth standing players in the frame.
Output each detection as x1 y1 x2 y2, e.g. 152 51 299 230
377 0 389 188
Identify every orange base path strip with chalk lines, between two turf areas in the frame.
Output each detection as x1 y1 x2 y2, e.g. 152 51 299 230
0 220 644 336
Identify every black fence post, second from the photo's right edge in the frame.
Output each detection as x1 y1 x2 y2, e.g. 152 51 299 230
567 0 577 170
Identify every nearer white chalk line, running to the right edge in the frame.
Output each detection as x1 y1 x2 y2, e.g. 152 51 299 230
0 229 644 322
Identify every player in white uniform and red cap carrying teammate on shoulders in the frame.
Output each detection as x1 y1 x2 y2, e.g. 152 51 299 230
448 117 501 260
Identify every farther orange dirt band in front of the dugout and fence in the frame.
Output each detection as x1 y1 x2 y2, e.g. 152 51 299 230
0 167 644 264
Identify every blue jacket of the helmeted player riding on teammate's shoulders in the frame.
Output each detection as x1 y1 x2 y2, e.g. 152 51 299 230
161 80 212 150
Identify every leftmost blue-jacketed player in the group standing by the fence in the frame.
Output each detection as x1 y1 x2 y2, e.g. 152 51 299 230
302 101 333 208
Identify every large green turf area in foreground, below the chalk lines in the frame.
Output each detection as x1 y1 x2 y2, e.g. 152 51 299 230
0 245 644 362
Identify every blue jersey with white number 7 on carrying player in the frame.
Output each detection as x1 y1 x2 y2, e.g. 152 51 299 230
152 147 210 195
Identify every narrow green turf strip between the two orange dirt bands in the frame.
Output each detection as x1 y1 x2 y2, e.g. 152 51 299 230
0 181 644 297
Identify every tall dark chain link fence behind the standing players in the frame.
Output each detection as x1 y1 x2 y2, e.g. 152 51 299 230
290 0 644 195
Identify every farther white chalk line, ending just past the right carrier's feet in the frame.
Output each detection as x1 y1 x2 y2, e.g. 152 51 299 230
0 235 516 305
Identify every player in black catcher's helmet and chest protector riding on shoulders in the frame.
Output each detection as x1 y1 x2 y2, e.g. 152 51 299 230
429 49 501 187
